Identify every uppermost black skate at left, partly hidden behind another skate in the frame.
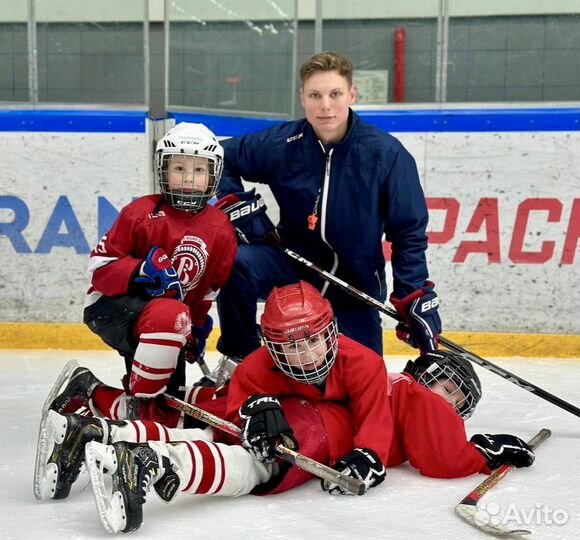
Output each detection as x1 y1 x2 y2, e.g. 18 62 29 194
42 360 104 416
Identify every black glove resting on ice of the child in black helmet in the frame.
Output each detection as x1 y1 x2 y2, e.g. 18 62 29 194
470 434 536 471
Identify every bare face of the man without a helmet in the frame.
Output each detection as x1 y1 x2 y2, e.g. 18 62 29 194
300 71 356 144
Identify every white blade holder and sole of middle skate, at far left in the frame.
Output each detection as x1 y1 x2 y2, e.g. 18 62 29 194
33 411 67 500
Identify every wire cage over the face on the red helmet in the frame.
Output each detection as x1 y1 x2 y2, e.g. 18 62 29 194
264 318 338 384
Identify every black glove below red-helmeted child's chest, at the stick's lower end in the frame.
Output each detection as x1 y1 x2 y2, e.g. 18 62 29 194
321 448 387 495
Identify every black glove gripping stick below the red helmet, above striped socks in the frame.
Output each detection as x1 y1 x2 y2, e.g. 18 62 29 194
240 394 298 463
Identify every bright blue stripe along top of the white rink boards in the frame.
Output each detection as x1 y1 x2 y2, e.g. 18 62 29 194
0 107 580 136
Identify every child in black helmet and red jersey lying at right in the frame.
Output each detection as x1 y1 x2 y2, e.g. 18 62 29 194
387 350 534 478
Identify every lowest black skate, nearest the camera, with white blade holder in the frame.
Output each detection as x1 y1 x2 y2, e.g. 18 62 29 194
85 442 179 533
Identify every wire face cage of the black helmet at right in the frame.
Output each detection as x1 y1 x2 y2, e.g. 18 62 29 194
417 361 481 420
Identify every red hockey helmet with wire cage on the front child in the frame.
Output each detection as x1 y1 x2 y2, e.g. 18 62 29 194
261 281 338 384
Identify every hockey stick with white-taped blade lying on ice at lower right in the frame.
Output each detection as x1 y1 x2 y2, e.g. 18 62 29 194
455 428 552 536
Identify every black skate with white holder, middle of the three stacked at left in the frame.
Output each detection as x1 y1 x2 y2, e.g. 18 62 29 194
34 410 110 499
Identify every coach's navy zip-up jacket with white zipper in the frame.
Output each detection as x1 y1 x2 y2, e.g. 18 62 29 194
219 111 428 303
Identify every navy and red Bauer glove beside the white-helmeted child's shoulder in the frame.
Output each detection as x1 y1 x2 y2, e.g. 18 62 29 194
215 189 280 244
